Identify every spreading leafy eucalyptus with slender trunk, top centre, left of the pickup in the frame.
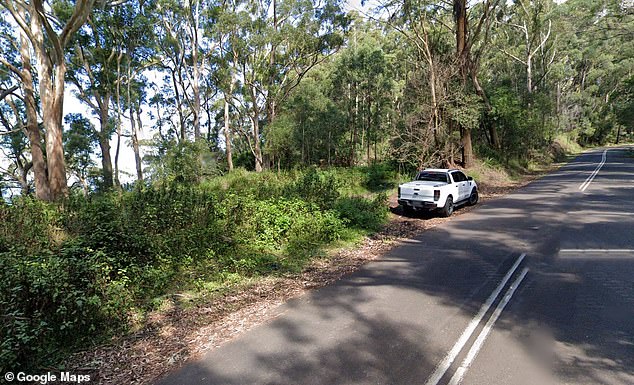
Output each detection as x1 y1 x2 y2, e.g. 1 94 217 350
226 0 348 171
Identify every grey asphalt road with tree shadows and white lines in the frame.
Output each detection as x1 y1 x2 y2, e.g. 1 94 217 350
154 147 634 385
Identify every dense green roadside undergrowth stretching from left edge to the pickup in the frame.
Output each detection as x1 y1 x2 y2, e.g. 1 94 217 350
0 168 387 372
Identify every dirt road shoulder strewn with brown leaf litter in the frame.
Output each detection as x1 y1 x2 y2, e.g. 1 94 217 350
65 168 543 385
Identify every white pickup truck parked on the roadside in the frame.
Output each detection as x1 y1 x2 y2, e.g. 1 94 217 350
398 169 478 217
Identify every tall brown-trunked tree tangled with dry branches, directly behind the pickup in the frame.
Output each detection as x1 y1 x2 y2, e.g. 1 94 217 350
381 0 500 167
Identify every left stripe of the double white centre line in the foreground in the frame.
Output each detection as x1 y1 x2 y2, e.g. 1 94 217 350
425 253 526 385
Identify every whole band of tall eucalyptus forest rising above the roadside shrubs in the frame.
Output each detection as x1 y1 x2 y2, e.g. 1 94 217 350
0 0 634 195
